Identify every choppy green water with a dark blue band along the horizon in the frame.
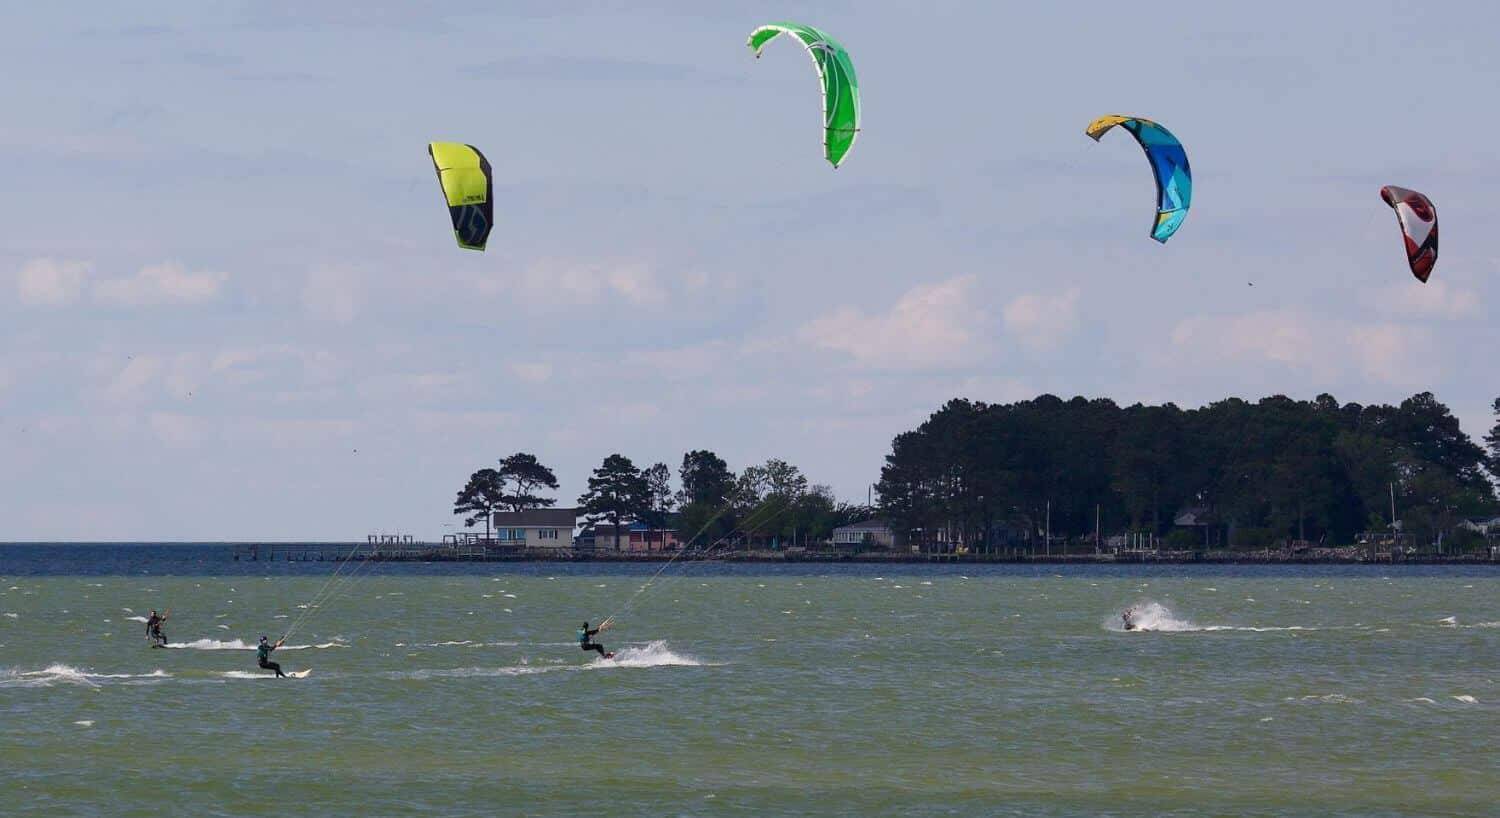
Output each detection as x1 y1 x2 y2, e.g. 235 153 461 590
0 546 1500 816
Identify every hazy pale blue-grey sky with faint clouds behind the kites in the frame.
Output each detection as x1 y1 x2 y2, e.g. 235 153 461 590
0 0 1500 540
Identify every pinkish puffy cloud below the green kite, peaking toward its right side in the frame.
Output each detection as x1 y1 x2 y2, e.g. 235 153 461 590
800 276 983 369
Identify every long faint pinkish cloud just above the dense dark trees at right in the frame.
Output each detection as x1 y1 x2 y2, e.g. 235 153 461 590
1172 309 1440 387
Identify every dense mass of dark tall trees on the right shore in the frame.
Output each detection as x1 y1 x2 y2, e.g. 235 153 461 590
879 392 1500 551
